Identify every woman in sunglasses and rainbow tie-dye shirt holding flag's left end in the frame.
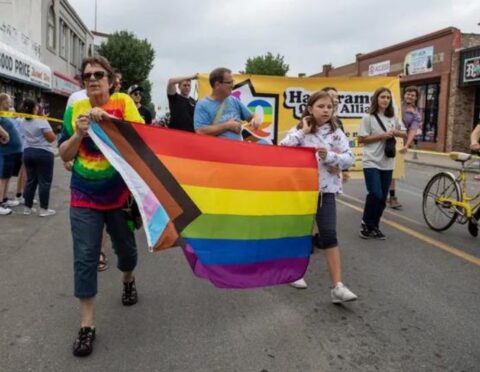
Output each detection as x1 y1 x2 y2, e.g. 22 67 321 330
59 57 143 356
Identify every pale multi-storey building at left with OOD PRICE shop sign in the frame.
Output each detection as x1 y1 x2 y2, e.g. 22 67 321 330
0 0 93 118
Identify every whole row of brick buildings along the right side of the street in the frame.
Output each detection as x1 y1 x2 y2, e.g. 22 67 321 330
314 27 480 152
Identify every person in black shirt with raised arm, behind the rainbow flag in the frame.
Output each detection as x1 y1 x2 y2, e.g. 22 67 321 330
167 74 198 133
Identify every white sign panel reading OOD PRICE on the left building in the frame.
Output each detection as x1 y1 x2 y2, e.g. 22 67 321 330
0 42 52 90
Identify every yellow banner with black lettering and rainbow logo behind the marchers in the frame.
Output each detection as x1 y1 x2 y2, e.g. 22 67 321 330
198 74 404 178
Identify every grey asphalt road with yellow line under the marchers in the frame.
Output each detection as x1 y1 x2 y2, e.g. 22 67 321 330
0 159 480 372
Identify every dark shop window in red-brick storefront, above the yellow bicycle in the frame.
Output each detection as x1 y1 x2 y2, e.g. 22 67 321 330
402 83 440 142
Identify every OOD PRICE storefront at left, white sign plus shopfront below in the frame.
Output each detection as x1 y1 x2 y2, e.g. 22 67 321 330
0 42 52 110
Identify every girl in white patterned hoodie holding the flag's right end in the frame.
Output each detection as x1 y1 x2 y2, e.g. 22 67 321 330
280 91 357 303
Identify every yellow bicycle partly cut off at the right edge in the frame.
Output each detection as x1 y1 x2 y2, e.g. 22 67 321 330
422 152 480 231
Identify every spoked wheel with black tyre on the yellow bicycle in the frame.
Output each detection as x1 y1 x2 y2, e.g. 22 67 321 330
422 172 461 231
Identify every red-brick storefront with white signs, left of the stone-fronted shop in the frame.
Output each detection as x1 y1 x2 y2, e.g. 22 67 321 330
357 32 460 151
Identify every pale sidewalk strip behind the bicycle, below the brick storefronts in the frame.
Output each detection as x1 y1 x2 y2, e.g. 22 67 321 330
405 150 480 174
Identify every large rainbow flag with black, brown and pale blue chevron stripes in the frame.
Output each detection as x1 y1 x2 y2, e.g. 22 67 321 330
90 120 318 288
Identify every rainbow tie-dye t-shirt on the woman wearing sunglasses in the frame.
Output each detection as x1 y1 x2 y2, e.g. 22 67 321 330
59 93 143 210
